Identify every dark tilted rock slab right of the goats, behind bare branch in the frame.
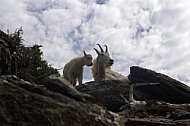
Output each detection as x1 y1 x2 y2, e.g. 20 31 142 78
129 66 190 104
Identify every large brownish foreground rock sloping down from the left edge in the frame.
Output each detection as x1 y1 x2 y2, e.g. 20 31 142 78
0 75 124 126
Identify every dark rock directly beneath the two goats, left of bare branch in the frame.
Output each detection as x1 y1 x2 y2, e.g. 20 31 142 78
76 80 130 112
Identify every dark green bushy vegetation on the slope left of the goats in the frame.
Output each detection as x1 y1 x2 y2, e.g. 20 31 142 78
0 27 59 82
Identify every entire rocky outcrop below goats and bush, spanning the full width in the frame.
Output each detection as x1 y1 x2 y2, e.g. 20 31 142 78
0 66 190 126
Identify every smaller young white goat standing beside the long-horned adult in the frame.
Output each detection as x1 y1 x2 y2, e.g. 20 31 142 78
63 51 93 86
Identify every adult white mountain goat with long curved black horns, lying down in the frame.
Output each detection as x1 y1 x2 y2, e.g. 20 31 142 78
92 44 129 82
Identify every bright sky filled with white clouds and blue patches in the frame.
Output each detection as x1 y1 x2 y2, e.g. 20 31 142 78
0 0 190 85
